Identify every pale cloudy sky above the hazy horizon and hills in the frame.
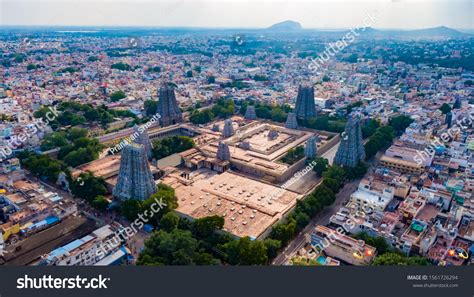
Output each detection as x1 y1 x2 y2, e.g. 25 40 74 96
0 0 474 29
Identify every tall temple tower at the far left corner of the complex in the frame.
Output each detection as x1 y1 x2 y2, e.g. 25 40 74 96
156 84 183 127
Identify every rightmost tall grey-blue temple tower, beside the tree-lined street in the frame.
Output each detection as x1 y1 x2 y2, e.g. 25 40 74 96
334 115 365 168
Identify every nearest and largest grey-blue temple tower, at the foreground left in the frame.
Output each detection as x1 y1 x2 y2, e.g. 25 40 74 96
112 143 156 201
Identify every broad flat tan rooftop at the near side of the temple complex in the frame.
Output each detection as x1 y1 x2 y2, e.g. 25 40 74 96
162 169 301 238
